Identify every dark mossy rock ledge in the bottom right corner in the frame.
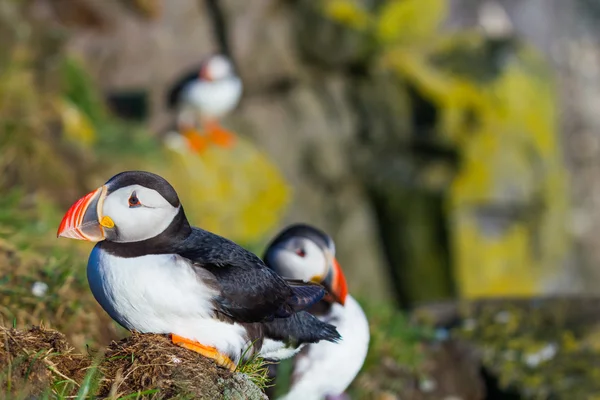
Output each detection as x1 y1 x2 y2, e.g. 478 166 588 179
414 297 600 399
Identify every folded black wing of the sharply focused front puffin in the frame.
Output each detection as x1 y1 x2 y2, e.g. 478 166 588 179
177 228 325 322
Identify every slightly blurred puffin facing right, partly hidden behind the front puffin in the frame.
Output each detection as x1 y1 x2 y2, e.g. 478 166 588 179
263 224 370 400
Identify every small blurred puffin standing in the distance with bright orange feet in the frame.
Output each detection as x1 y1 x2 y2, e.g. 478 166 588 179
167 54 243 153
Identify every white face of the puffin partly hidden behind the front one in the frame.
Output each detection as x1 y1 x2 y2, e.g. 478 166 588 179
267 237 328 282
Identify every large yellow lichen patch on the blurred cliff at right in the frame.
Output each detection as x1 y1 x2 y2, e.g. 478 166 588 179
316 0 569 298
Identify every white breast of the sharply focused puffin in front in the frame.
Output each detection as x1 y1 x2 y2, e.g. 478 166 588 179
87 247 216 333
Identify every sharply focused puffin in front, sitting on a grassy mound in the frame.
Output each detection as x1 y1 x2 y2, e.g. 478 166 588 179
57 171 341 370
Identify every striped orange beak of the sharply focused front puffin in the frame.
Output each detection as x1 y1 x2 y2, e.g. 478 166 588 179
56 186 109 242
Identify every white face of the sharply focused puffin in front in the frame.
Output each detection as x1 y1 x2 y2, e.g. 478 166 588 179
102 185 179 243
